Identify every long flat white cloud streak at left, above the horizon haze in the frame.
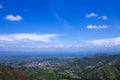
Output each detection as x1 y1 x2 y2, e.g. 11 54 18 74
0 33 59 42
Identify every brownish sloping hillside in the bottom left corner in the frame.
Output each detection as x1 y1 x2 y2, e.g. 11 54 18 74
0 65 40 80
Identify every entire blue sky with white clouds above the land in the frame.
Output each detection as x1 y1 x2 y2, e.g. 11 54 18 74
0 0 120 52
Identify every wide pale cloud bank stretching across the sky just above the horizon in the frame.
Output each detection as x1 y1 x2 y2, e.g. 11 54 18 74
0 33 120 51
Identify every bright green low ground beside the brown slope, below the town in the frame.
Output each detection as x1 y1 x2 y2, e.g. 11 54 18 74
20 67 61 80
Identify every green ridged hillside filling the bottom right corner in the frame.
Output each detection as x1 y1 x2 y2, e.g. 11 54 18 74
81 65 120 80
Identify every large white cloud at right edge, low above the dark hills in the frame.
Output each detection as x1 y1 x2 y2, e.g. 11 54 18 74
89 37 120 47
